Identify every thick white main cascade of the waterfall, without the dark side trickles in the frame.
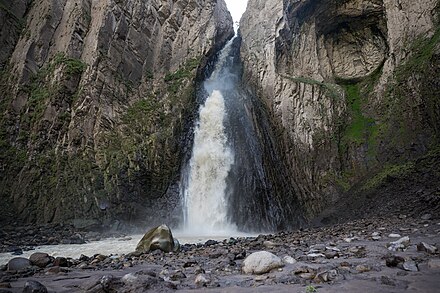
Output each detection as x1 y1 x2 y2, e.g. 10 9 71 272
183 40 236 235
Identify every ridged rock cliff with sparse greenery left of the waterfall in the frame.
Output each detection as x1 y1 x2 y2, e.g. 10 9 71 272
0 0 233 225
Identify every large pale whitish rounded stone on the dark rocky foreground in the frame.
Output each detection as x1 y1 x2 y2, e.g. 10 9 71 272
242 251 284 275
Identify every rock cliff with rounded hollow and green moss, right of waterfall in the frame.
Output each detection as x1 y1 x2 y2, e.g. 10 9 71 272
240 0 440 218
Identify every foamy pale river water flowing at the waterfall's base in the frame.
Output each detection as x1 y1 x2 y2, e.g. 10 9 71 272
0 233 254 265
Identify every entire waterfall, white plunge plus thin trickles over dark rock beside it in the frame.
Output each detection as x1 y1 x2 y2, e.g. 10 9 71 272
180 37 297 236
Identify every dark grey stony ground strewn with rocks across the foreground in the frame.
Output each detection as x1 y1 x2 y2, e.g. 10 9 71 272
0 214 440 292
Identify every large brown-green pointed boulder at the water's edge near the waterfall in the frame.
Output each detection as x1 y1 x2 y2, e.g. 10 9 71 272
136 225 180 253
